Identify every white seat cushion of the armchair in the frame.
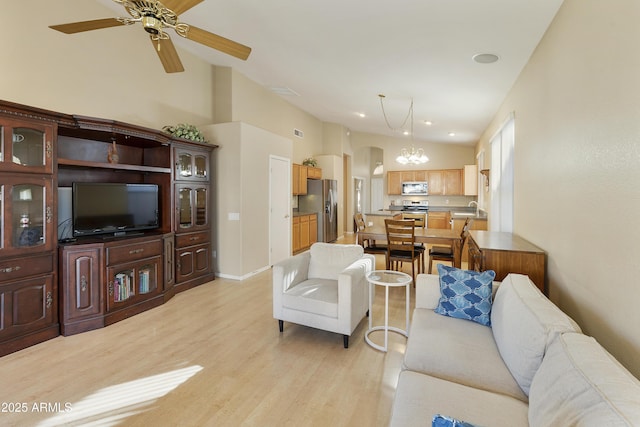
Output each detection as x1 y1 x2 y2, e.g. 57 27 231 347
282 279 338 317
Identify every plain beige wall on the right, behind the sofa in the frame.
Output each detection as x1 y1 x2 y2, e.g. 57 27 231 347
478 0 640 376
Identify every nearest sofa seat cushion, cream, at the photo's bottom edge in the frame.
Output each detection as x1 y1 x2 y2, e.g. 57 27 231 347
390 372 529 427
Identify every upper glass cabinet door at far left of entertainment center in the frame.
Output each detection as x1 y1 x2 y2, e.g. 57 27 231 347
0 120 53 173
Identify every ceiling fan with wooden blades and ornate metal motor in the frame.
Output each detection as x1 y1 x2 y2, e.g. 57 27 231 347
49 0 251 73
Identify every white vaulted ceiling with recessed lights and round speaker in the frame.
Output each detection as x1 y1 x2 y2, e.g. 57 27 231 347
94 0 562 145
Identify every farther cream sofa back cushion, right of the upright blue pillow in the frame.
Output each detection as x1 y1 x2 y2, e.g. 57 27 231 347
491 274 580 395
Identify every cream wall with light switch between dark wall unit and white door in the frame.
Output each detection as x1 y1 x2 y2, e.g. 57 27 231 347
202 122 292 279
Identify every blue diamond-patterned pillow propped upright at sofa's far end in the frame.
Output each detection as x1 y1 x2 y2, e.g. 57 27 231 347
435 264 496 326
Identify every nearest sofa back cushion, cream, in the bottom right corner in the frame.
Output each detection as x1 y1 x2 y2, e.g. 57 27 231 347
529 333 640 427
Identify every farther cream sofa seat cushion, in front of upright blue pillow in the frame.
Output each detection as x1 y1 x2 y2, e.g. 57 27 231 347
403 308 527 402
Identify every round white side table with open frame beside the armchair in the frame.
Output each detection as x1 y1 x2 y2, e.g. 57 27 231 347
364 270 411 352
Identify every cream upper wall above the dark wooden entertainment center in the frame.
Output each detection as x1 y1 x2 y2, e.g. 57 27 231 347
0 0 214 129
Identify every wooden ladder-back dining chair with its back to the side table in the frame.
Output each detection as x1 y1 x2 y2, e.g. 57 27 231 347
384 219 420 283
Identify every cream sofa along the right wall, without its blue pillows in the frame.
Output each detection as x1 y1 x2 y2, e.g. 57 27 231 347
390 274 640 427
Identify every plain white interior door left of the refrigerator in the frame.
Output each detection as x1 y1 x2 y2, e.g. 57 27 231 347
269 156 292 265
